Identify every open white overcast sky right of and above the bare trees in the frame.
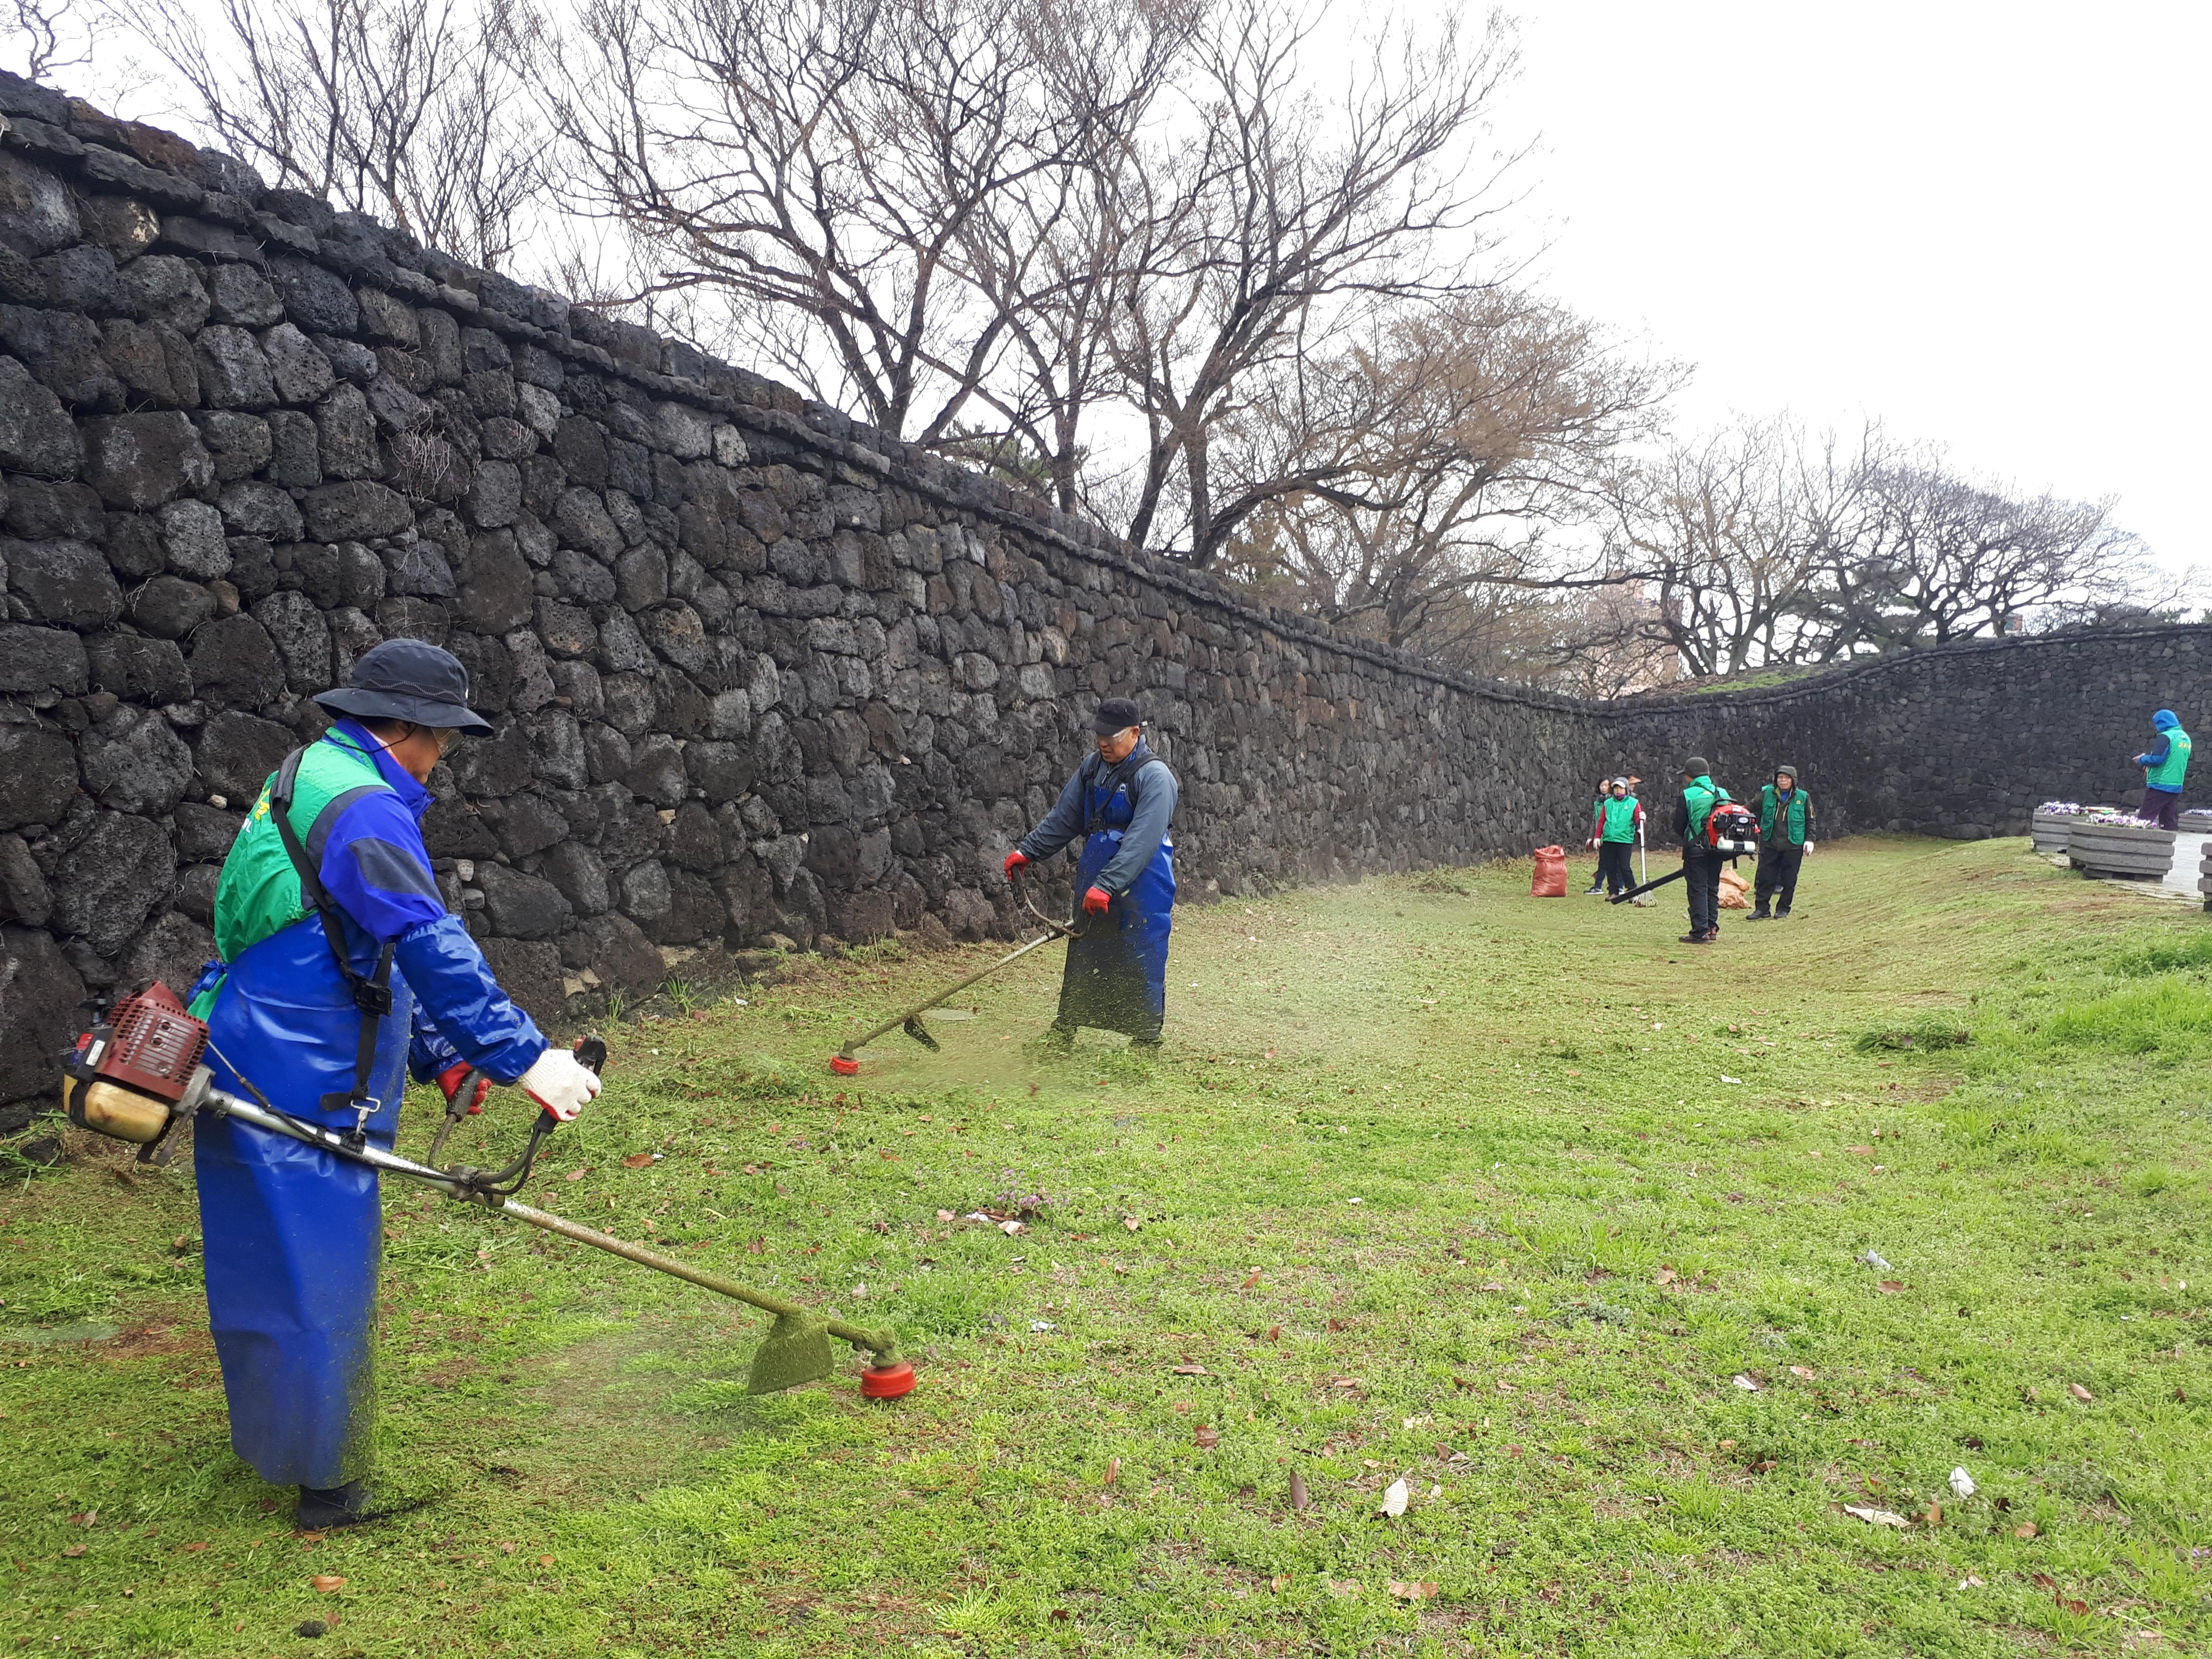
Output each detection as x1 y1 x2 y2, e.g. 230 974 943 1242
1498 0 2212 566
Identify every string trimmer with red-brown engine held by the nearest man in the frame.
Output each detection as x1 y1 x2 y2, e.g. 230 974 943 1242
62 980 914 1400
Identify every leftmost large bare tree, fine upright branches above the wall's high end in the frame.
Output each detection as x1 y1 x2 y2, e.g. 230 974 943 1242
95 0 549 270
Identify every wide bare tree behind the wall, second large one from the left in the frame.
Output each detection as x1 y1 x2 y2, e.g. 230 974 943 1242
551 0 1106 443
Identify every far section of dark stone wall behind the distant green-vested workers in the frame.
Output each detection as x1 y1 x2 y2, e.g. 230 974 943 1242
1606 626 2212 841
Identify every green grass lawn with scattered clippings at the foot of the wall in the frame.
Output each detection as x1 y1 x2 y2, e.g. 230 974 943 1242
0 841 2212 1659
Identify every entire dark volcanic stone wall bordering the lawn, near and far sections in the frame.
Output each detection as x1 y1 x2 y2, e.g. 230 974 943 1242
0 75 2205 1128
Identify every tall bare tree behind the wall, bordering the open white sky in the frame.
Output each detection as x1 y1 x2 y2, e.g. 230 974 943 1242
1115 0 1515 566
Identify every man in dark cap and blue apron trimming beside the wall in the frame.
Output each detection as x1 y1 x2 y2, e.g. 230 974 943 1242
1007 697 1179 1048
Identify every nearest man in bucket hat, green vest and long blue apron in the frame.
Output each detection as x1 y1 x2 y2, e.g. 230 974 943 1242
192 639 600 1528
